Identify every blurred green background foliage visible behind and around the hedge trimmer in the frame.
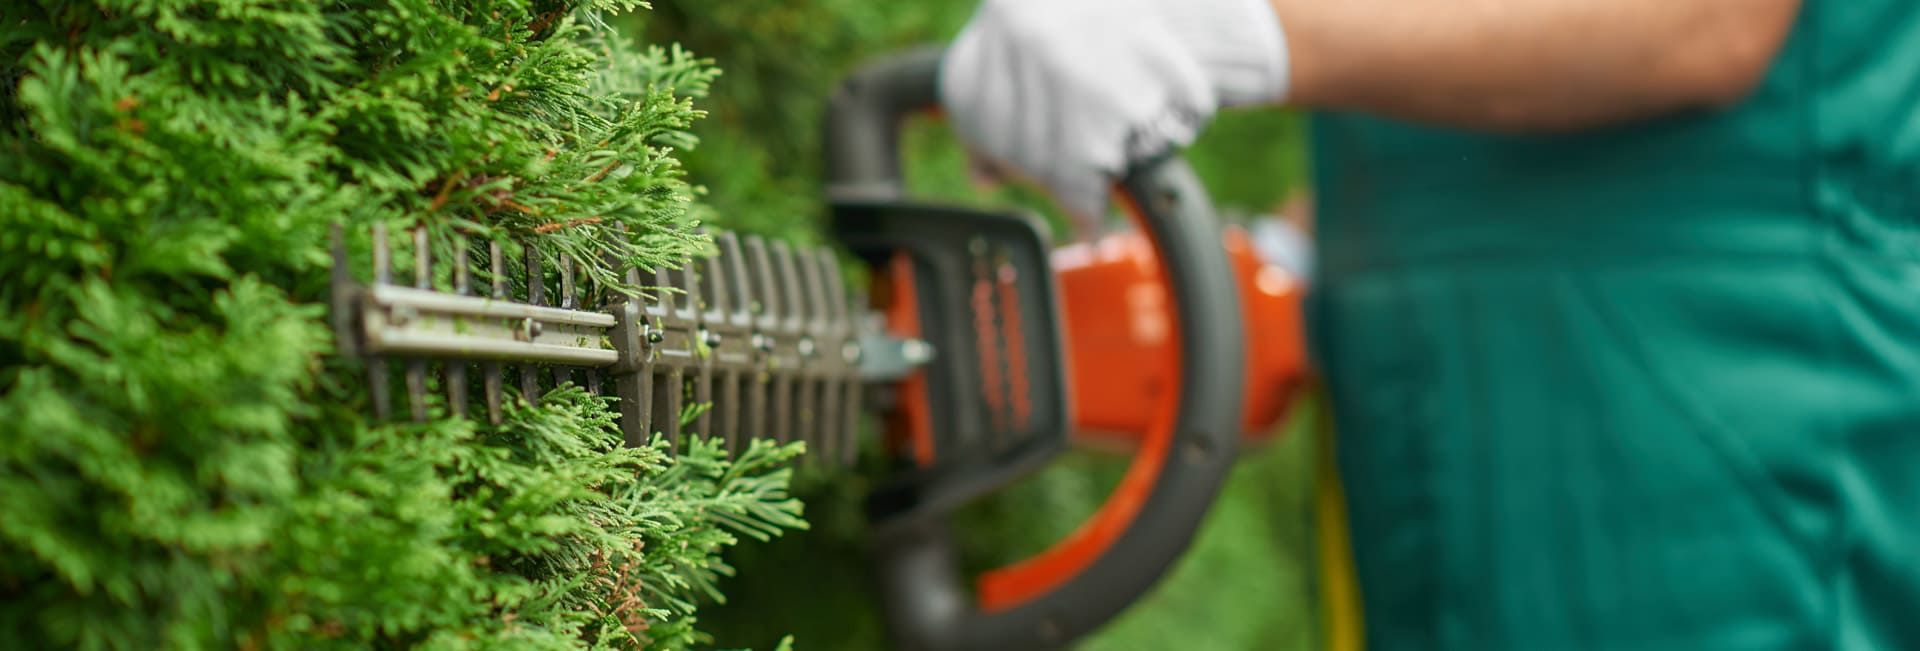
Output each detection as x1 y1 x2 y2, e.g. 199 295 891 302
624 0 1317 649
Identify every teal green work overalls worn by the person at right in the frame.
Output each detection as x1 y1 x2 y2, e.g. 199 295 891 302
1309 0 1920 651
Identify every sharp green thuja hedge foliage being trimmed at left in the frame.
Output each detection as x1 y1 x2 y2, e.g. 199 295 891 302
0 0 803 649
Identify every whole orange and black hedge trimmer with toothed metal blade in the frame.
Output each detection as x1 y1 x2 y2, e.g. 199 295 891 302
334 52 1302 649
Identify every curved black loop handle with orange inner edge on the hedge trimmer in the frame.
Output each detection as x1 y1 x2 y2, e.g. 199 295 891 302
826 48 1244 649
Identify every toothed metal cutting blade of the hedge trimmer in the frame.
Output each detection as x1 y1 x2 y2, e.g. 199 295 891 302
334 227 910 465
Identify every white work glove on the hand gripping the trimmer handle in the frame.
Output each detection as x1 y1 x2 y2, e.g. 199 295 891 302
941 0 1288 236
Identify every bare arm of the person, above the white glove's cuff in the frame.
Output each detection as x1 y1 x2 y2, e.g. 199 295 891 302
1271 0 1801 131
